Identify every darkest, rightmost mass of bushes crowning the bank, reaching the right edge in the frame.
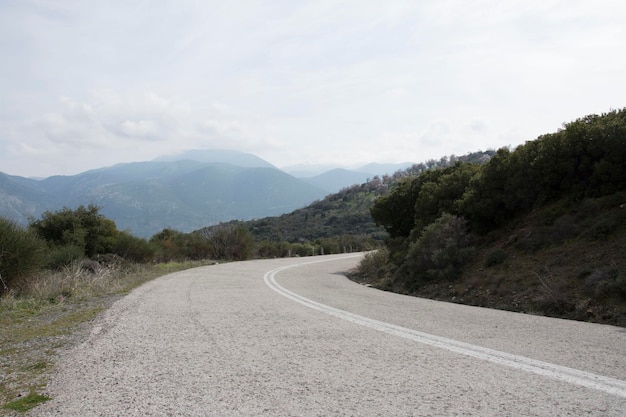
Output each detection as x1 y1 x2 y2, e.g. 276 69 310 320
459 109 626 232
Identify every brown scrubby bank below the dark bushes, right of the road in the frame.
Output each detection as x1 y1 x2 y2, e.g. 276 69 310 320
360 192 626 327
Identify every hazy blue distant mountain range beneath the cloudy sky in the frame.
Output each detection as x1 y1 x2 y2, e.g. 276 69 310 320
0 150 410 237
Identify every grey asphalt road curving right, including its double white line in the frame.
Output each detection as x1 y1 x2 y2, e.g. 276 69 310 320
30 255 626 417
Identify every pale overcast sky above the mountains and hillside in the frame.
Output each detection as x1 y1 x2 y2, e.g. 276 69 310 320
0 0 626 177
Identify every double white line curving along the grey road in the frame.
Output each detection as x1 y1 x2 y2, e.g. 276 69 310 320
263 255 626 398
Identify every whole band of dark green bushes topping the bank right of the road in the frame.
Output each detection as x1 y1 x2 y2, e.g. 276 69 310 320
369 110 626 291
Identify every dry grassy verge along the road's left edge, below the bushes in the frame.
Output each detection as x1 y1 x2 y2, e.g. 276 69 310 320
0 261 212 417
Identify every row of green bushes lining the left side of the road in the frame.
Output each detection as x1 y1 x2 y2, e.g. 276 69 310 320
0 205 374 295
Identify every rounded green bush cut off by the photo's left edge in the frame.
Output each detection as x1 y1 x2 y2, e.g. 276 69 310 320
0 217 46 294
